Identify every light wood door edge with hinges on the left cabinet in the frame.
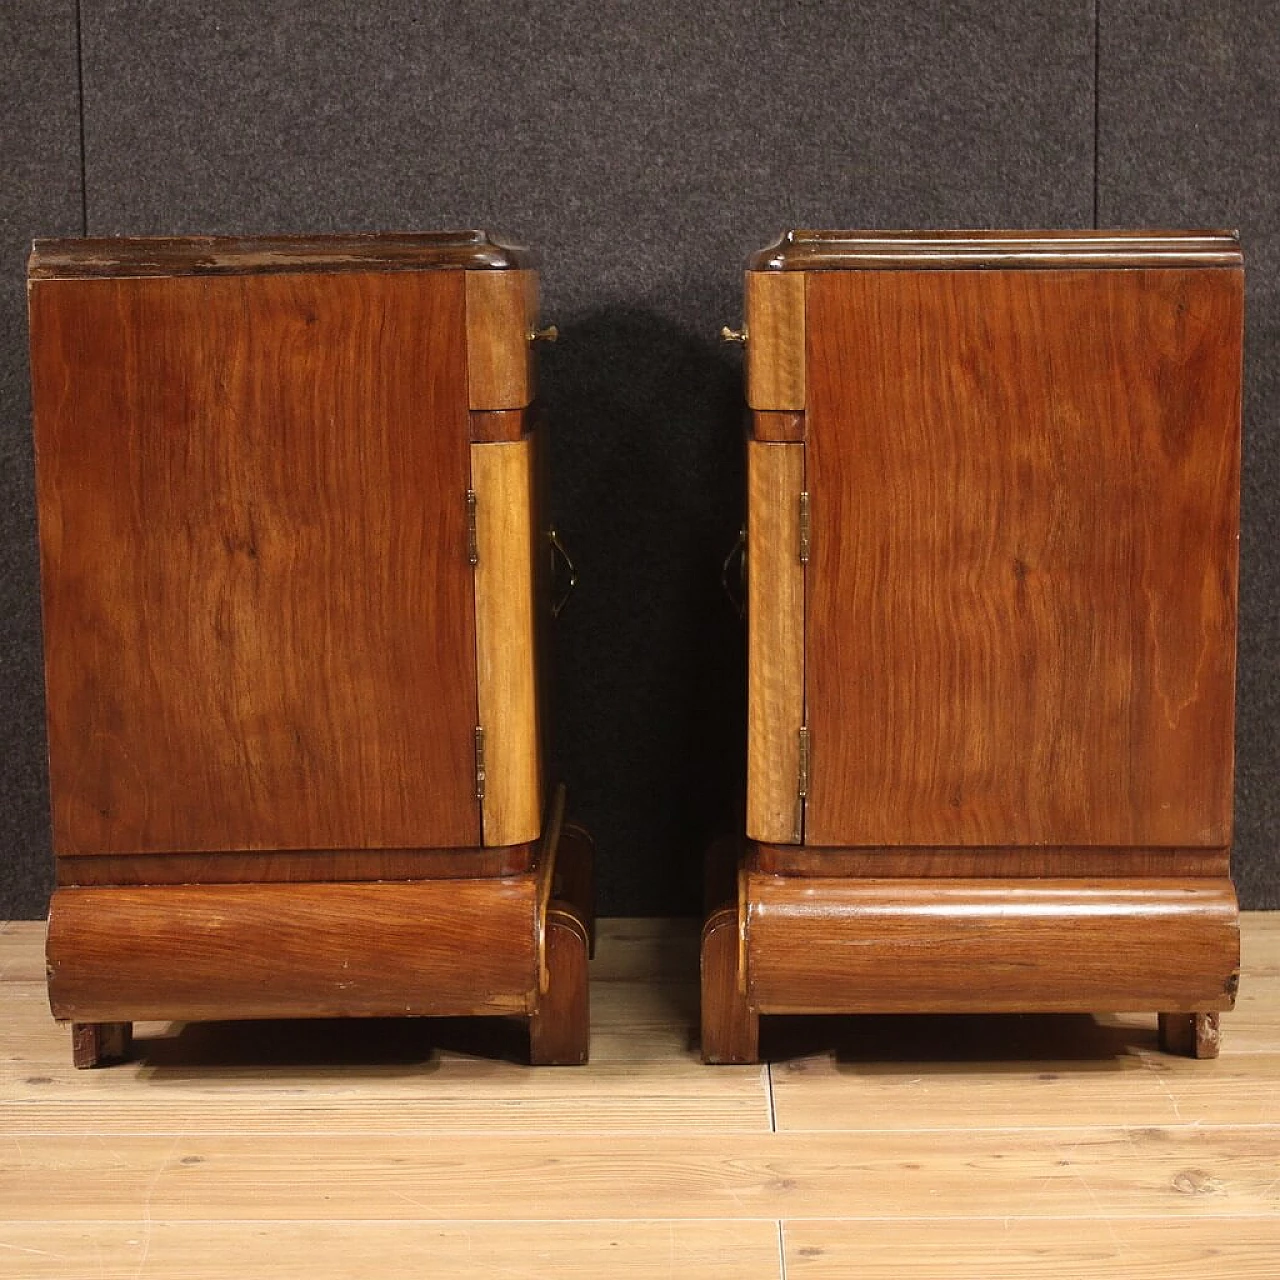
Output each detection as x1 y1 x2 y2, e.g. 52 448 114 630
471 435 543 845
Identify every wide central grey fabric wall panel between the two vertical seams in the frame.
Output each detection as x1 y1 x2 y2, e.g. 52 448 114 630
67 0 1093 914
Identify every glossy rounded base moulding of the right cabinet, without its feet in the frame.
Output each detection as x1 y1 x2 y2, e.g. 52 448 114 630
746 874 1240 1014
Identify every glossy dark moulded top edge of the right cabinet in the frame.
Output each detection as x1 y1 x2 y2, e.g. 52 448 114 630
746 230 1243 271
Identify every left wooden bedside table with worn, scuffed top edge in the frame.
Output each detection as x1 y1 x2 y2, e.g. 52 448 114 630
29 232 591 1066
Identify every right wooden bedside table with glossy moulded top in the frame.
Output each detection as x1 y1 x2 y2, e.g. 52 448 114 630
703 232 1243 1061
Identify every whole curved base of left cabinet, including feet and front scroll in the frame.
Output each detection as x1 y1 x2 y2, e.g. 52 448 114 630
46 800 594 1066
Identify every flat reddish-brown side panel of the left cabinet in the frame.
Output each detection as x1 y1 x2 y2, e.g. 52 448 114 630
31 271 480 852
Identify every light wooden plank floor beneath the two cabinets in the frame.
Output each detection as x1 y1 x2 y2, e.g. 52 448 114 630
0 914 1280 1280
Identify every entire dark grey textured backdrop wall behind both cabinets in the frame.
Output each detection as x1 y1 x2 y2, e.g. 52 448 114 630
0 0 1280 918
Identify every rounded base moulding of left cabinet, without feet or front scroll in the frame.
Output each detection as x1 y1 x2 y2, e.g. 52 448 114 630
47 876 538 1021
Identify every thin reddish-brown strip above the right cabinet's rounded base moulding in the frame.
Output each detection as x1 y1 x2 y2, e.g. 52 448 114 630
749 845 1231 879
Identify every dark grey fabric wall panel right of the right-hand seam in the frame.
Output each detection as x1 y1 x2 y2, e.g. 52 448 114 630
1098 0 1280 908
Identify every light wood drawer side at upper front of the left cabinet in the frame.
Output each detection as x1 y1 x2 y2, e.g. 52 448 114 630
466 271 538 410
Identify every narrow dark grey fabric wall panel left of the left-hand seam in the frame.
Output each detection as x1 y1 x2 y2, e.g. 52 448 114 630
0 0 81 919
